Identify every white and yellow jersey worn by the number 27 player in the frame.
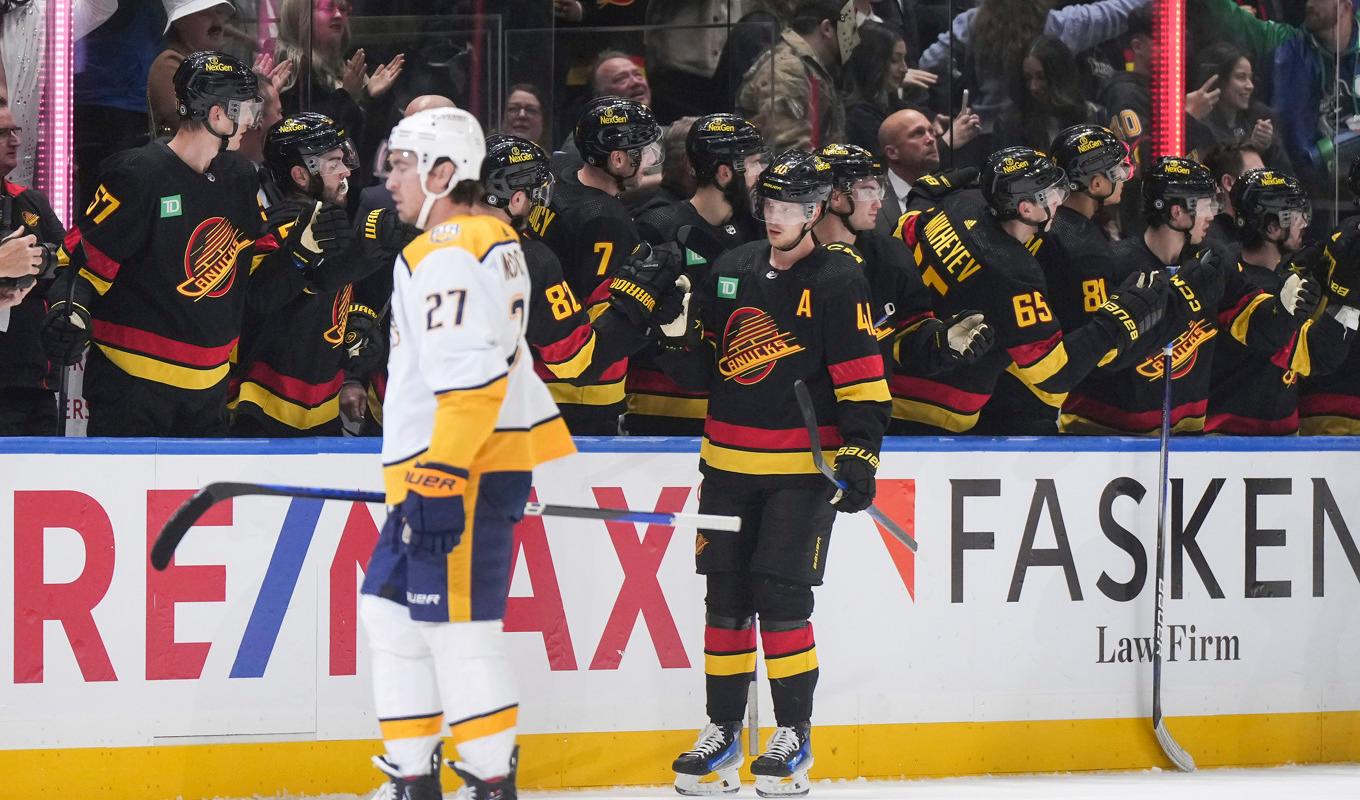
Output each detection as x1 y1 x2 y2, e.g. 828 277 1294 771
382 215 575 505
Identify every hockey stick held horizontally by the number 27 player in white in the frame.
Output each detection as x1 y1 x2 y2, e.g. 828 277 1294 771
151 482 741 570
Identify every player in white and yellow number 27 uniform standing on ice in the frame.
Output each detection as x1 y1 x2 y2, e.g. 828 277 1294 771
360 109 574 800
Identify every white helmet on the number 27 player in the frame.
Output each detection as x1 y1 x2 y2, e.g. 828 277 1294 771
388 109 487 229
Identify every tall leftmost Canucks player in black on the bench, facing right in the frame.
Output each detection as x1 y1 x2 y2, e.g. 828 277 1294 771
44 52 276 437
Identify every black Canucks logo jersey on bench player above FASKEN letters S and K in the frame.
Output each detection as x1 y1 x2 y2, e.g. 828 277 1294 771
1058 237 1299 434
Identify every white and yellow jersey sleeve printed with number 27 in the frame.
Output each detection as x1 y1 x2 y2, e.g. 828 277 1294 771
398 248 510 475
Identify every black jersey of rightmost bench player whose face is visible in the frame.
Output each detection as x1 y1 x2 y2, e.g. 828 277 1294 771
1204 261 1350 437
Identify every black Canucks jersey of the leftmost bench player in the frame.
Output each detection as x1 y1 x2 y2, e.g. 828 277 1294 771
58 141 266 390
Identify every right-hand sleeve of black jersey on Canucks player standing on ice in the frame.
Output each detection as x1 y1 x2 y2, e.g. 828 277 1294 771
819 262 892 453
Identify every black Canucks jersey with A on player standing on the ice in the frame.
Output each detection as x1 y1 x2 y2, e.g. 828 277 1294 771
658 241 889 487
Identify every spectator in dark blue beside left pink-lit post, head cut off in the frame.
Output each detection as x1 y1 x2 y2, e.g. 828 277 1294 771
73 1 165 208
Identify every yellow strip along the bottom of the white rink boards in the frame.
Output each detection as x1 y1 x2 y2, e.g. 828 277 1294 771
0 712 1360 800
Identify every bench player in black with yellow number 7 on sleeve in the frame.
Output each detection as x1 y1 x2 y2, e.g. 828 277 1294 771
529 97 662 435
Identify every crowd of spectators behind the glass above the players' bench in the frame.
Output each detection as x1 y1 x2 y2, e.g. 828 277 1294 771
0 0 1360 435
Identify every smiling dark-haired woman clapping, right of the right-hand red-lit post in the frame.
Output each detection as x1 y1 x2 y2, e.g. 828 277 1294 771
1186 42 1292 174
